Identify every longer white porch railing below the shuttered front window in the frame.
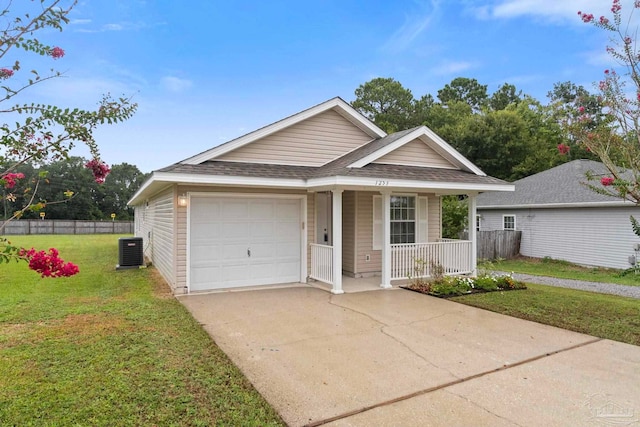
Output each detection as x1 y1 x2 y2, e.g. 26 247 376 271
391 239 473 280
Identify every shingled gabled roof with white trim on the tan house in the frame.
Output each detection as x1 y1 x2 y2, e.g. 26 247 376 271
129 98 513 205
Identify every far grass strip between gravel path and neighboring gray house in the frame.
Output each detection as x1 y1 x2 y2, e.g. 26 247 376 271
478 257 640 286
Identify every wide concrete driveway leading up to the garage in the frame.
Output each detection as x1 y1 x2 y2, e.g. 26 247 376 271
180 286 640 426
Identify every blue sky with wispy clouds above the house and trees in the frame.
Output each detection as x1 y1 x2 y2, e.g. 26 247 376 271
21 0 629 172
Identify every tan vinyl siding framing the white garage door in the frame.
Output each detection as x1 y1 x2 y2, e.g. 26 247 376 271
176 185 306 289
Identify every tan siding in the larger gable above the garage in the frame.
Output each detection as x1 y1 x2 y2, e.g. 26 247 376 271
216 110 372 166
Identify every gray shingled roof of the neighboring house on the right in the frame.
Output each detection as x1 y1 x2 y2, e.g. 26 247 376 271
477 160 631 209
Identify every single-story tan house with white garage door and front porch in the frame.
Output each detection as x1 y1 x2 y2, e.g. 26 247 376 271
129 98 513 294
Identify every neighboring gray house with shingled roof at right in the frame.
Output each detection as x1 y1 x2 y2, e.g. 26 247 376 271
476 160 640 269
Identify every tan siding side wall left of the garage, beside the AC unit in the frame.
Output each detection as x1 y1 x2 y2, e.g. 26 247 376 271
141 188 176 289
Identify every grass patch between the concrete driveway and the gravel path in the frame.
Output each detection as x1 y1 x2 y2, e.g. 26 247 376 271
451 283 640 345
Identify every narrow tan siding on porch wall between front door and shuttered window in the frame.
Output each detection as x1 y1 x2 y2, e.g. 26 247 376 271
354 191 382 276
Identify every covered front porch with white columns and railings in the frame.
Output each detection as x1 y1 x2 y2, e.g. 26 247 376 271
309 189 476 294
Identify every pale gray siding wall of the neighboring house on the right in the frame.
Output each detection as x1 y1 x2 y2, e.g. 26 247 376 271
478 207 640 269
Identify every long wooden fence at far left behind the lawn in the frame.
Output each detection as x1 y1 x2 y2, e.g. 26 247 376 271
0 219 134 235
